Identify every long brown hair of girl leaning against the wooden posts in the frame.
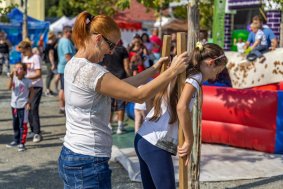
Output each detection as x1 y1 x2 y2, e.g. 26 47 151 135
150 43 227 124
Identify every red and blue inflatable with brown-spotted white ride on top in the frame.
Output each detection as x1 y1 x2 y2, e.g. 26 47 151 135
126 49 283 154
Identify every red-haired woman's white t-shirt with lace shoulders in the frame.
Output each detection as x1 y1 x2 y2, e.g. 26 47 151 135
64 57 112 157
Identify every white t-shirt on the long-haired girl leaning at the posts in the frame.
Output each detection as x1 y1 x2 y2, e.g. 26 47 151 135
137 73 202 155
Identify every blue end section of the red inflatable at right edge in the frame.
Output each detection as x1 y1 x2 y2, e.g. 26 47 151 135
274 91 283 154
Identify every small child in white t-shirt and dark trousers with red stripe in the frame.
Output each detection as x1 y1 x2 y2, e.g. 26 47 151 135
6 63 33 152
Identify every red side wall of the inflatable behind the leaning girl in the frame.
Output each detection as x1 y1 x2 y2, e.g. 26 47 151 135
202 86 277 153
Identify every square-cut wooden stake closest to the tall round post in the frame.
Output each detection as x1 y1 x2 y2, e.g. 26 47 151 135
177 32 188 189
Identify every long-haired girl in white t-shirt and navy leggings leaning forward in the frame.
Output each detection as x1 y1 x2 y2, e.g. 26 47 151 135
135 43 227 189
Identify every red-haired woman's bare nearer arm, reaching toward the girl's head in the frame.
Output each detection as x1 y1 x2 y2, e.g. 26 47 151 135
96 53 188 103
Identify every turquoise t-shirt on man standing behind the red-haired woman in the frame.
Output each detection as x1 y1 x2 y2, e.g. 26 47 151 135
57 37 75 74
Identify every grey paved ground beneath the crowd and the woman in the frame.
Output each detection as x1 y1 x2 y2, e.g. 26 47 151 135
0 65 283 189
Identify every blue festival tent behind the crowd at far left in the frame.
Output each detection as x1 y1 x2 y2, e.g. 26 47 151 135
0 8 49 64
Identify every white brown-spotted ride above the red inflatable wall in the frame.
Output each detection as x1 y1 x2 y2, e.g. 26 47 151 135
225 48 283 89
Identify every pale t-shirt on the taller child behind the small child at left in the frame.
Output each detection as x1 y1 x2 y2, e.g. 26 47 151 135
22 54 43 87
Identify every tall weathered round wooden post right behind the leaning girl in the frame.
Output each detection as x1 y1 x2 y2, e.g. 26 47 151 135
187 0 201 189
